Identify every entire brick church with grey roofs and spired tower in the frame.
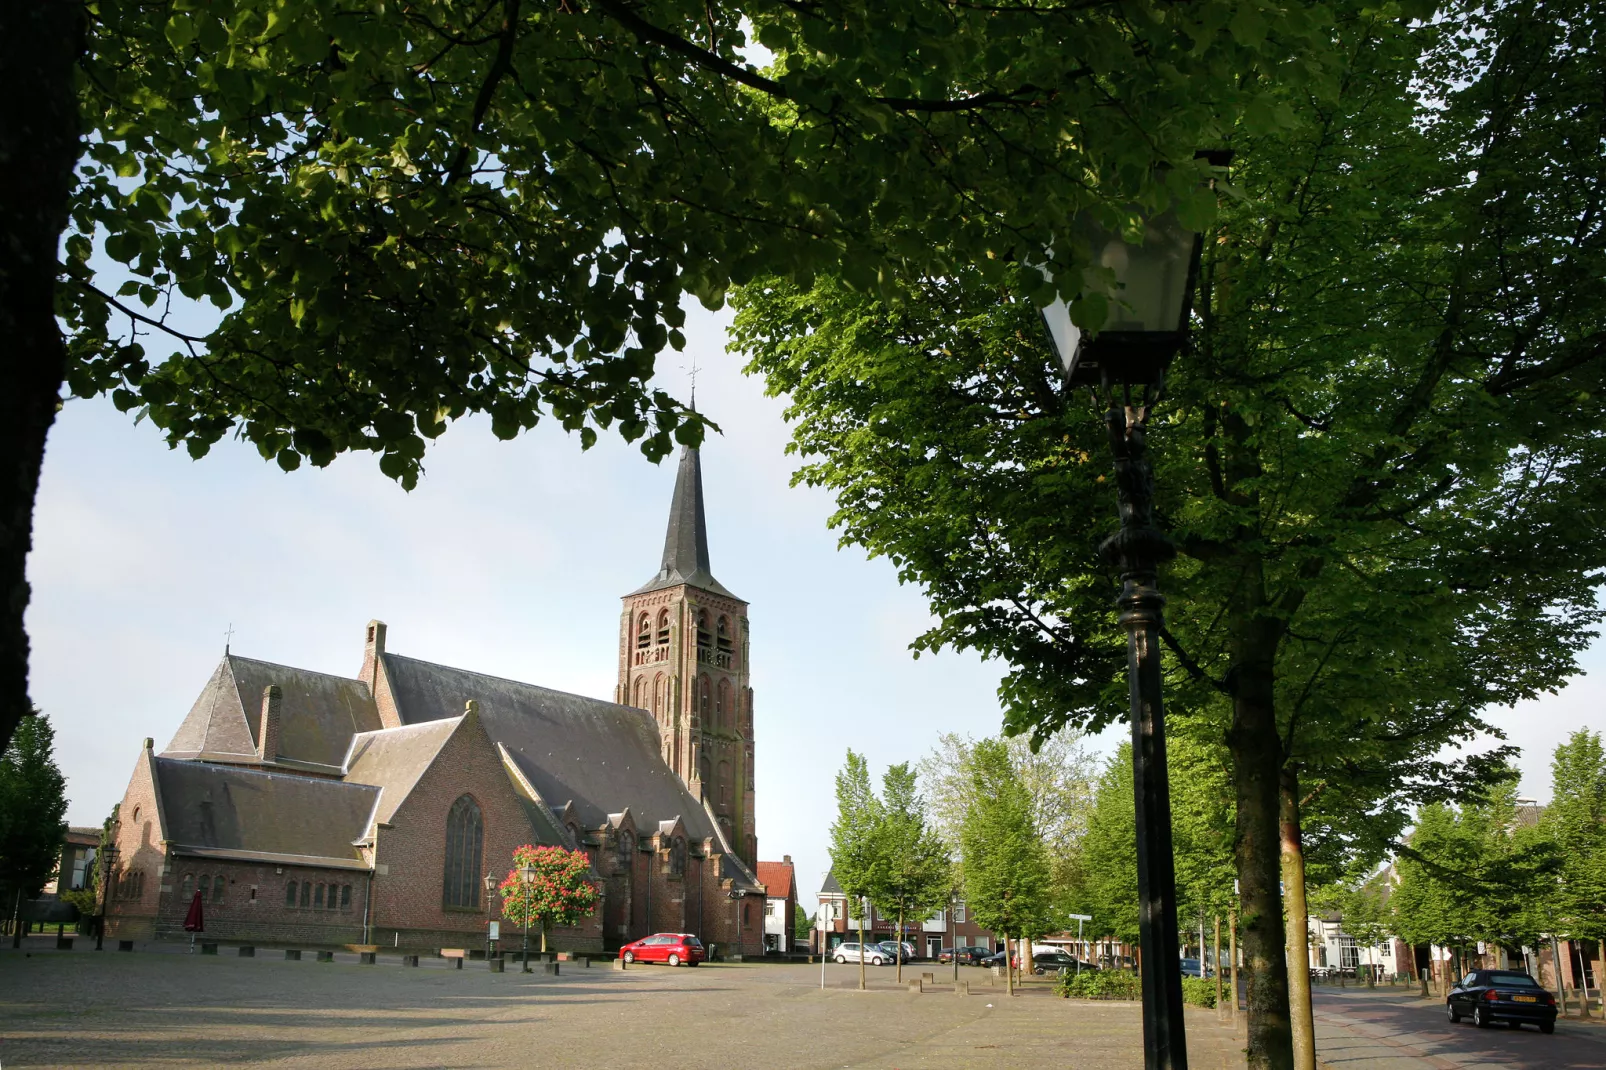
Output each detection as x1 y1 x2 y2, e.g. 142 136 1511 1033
108 448 764 954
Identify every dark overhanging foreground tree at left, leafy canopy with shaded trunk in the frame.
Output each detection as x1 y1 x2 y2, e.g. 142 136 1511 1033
0 0 1335 755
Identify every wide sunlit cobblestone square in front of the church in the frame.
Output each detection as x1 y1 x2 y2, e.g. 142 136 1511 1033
0 948 1246 1070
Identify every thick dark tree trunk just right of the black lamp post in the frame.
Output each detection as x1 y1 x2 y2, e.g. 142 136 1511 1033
1227 557 1293 1070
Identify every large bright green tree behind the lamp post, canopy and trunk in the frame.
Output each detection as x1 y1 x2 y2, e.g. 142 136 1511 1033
737 2 1606 1067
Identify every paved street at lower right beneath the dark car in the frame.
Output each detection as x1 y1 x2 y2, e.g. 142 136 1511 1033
1312 986 1606 1070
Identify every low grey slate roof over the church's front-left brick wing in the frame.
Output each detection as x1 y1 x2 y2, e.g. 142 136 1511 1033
154 748 379 869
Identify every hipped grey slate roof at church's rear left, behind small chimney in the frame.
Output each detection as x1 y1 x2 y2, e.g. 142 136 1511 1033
162 654 381 770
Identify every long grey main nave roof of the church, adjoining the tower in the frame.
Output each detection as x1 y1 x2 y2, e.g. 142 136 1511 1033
375 652 715 839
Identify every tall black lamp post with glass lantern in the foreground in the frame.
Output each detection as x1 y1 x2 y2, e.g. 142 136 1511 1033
1042 154 1230 1070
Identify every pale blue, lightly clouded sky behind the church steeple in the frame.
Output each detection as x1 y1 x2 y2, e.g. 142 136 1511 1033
27 300 1606 909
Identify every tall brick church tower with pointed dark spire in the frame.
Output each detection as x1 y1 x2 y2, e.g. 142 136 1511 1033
615 447 758 868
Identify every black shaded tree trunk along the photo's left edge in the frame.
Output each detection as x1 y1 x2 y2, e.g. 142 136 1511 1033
0 0 84 749
